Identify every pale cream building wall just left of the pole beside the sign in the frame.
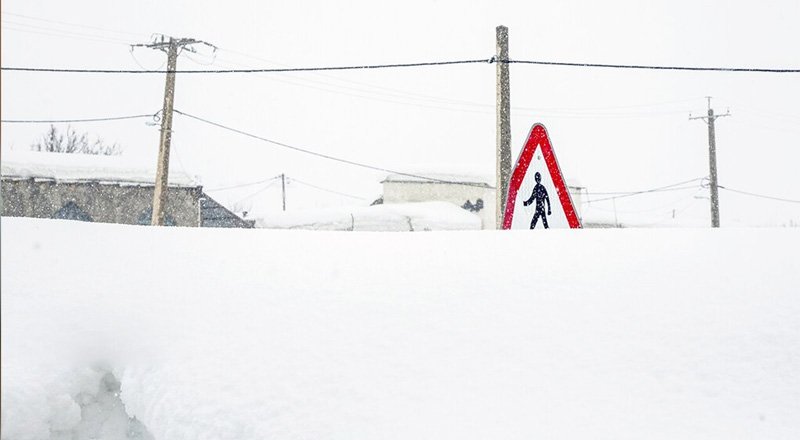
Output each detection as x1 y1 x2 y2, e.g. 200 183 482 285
383 181 495 229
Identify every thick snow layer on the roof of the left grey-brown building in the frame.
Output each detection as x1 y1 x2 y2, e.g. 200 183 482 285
0 151 200 187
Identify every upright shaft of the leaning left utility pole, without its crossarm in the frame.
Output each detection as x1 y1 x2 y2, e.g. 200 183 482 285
150 38 178 226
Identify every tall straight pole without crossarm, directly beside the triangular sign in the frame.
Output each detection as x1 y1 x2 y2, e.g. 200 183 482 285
495 26 511 229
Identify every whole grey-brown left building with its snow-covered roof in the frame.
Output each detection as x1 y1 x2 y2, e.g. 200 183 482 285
0 151 252 227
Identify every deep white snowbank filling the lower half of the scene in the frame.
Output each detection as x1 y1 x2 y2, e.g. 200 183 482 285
0 218 800 440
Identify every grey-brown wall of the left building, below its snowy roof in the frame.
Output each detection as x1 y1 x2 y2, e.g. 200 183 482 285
0 178 201 226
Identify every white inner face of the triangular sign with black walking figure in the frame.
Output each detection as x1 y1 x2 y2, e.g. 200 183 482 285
511 147 570 229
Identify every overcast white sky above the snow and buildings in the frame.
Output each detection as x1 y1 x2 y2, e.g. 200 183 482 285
2 0 800 226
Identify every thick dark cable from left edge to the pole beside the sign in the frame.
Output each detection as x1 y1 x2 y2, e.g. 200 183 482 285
0 59 490 74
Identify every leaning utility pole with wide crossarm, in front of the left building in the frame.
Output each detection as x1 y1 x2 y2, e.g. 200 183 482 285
131 35 216 226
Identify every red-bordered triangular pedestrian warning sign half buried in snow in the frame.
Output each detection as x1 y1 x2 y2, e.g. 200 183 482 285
503 124 581 229
